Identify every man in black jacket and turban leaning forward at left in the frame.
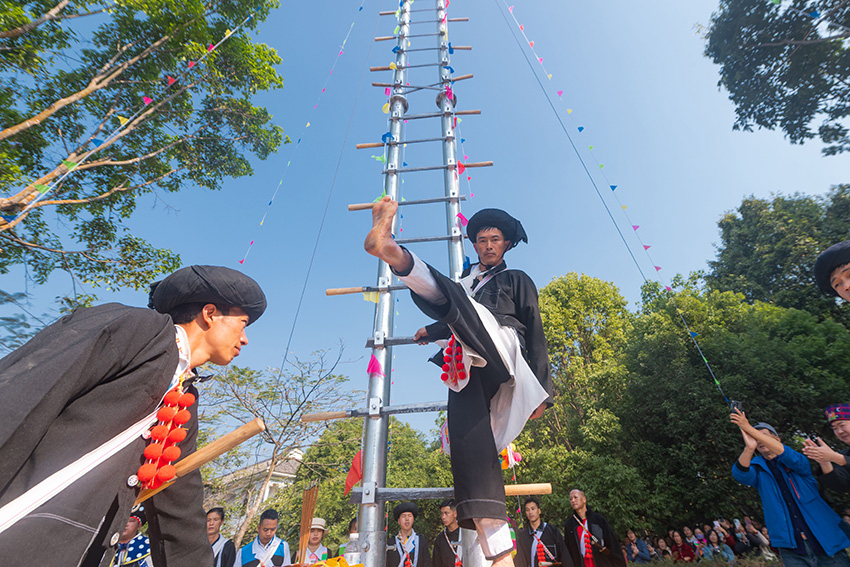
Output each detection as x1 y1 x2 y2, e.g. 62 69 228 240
0 266 266 567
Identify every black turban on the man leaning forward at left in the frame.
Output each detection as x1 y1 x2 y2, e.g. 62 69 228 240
148 266 266 325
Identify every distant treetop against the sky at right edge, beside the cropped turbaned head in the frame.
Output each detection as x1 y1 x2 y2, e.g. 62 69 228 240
706 185 850 326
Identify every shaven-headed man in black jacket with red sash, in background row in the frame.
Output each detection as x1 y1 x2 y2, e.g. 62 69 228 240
564 488 626 567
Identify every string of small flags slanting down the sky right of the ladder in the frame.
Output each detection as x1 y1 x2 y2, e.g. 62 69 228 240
502 0 724 403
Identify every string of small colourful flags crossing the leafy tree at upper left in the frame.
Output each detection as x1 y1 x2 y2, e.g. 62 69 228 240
2 14 254 223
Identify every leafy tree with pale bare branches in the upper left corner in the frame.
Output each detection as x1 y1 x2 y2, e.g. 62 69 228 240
0 0 285 289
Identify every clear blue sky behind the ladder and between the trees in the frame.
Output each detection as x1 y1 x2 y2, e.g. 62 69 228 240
3 0 847 430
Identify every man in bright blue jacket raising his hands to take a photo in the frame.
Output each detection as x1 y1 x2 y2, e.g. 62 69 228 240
731 409 850 567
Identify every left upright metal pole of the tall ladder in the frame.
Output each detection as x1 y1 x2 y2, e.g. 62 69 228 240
357 0 410 567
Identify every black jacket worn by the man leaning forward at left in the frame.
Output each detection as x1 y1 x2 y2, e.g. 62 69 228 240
0 303 212 567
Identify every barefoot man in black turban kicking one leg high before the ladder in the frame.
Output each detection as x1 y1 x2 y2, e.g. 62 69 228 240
365 197 552 567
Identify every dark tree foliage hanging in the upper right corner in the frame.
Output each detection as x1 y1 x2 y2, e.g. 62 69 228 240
705 0 850 155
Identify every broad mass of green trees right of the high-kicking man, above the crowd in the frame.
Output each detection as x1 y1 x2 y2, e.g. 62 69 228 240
510 274 850 535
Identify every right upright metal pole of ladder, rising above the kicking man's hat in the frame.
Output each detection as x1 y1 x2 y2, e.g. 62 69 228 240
436 0 465 280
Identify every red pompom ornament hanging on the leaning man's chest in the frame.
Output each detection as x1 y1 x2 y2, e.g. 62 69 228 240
136 384 195 489
